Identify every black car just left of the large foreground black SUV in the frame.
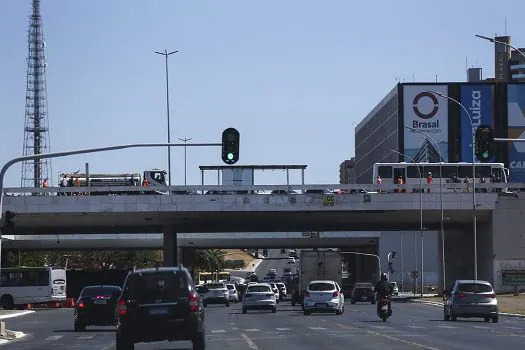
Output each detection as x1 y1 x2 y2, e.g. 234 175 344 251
73 285 122 332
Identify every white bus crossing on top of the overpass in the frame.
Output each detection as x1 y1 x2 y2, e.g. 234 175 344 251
372 162 509 192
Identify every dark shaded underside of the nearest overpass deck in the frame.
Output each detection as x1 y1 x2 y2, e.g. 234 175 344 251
4 210 491 235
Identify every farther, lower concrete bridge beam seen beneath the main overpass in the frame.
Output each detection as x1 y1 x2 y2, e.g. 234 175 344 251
2 231 381 250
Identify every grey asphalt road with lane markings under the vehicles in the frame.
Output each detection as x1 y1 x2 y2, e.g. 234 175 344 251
5 251 525 350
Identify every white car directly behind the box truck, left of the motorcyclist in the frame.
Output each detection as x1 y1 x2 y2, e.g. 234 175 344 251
303 280 345 315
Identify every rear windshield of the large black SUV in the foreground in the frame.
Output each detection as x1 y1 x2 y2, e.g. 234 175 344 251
125 271 188 303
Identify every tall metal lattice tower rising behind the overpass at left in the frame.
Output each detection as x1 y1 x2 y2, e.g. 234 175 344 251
21 0 52 187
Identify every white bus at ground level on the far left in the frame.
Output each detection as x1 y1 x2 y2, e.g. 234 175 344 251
0 267 67 310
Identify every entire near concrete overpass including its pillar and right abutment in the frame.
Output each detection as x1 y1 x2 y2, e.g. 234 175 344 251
3 184 525 290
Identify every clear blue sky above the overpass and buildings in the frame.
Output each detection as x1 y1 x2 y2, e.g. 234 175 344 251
0 0 525 186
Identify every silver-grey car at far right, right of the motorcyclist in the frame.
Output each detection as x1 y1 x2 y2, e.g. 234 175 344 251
443 280 498 323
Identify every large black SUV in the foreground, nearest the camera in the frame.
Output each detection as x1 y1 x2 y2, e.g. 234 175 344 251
116 267 206 350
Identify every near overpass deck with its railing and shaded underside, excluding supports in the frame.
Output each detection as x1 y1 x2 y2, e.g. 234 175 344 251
3 184 498 235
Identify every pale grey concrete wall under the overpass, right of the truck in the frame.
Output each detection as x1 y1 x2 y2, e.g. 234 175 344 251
379 231 439 291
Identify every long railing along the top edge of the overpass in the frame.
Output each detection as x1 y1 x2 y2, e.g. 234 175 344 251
0 183 525 196
